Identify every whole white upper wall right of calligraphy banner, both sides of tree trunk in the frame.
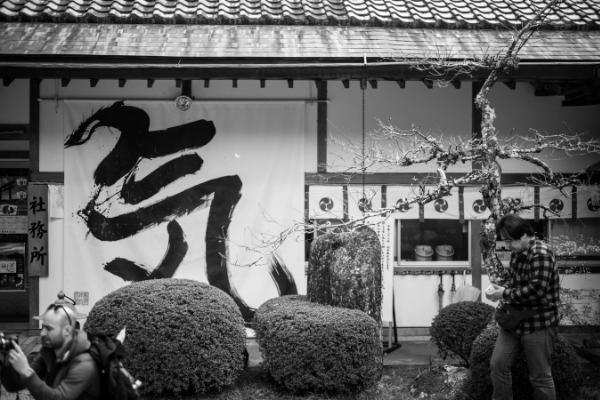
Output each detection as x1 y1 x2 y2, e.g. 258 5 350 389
327 81 600 173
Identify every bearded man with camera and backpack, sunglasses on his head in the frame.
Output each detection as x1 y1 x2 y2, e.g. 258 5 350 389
0 295 101 400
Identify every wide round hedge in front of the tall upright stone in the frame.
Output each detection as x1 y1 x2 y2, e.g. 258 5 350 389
254 296 383 393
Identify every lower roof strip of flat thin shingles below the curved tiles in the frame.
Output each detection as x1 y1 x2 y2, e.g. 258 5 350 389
0 22 600 63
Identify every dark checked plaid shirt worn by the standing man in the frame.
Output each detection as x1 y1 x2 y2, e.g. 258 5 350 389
502 240 559 335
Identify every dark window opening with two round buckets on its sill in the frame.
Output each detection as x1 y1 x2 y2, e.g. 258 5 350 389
397 219 469 264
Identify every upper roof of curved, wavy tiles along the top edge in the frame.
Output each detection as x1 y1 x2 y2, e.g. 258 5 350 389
0 0 600 29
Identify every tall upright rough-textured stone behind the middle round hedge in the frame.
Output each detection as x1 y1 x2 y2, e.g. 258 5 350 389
307 227 381 322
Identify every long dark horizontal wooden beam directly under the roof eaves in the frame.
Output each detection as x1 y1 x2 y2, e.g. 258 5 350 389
0 61 598 82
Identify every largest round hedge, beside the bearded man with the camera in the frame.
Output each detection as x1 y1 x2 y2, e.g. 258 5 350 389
85 279 246 395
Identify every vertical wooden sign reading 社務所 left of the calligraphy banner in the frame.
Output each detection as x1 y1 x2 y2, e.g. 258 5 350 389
27 184 49 276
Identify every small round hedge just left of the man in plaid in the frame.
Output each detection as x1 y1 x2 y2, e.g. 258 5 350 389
431 301 494 367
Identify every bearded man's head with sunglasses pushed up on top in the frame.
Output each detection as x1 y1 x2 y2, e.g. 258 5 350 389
39 303 77 351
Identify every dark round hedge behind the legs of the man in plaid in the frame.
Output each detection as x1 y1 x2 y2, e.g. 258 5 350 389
465 324 581 400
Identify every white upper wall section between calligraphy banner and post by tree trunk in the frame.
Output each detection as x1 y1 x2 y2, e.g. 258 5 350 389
327 81 472 172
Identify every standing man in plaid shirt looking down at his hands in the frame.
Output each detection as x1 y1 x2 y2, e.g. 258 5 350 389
486 214 559 400
